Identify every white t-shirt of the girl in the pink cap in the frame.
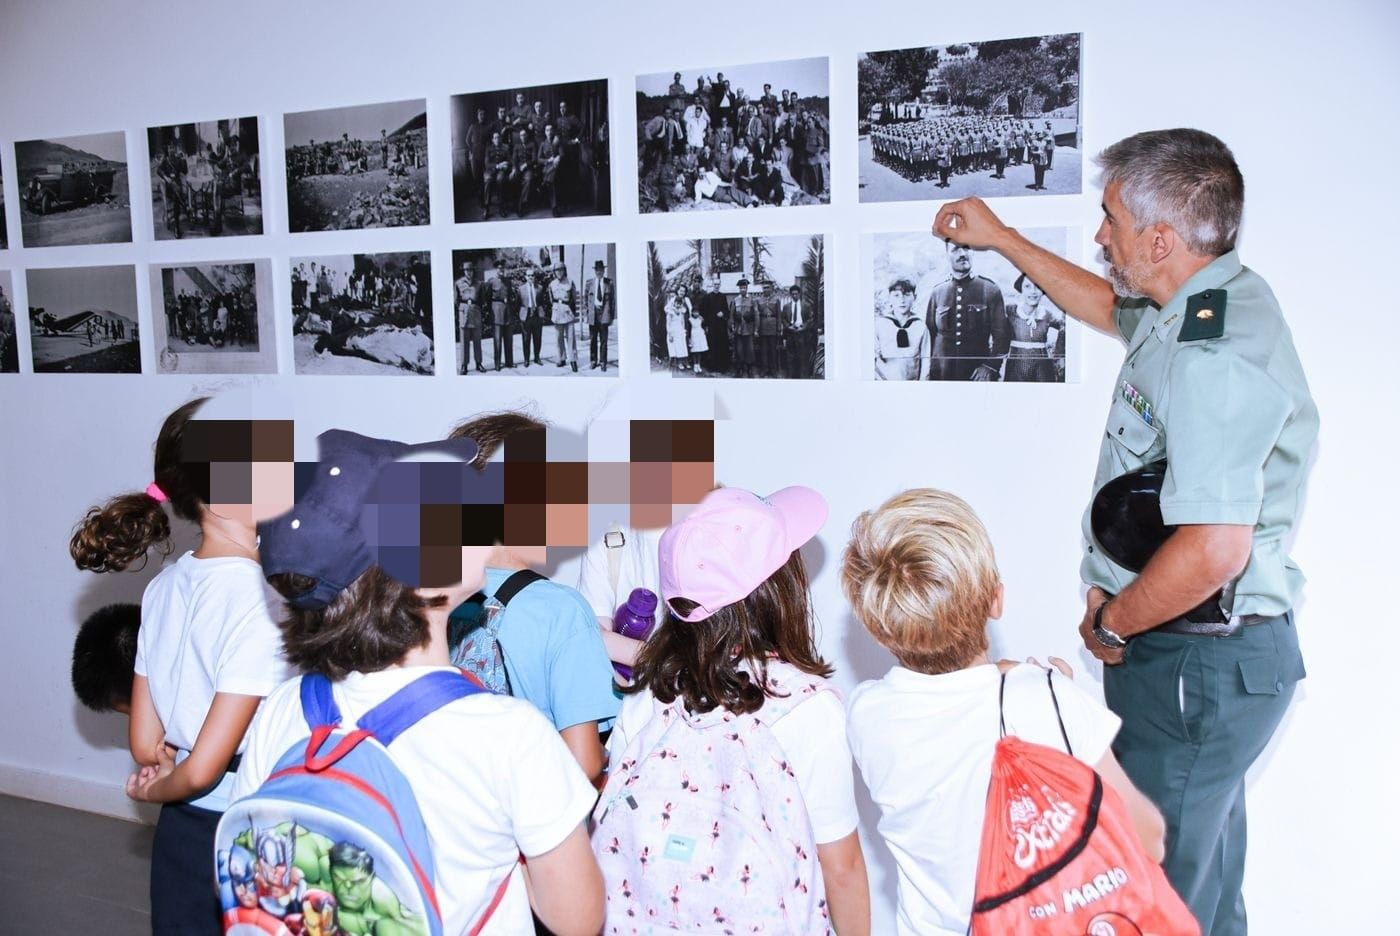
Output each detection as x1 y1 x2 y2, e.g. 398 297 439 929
608 668 860 845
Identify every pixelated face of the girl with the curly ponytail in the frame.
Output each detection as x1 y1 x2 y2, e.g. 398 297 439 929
181 420 295 525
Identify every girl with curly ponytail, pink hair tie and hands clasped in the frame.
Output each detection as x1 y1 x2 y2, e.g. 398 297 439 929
69 399 291 935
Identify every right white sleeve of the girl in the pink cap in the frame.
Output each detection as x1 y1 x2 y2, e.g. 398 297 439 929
773 693 860 845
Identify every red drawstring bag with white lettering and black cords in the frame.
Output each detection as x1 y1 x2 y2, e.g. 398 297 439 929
969 672 1201 936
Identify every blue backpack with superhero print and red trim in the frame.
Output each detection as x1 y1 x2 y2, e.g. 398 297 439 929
214 670 511 936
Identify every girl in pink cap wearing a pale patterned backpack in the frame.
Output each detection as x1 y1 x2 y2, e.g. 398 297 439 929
594 487 869 936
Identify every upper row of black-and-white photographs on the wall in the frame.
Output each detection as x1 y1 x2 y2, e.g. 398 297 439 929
0 34 1081 248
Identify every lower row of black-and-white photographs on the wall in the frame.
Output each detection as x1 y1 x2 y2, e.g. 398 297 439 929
0 228 1071 383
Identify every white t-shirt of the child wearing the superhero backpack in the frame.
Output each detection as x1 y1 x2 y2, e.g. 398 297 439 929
232 666 598 936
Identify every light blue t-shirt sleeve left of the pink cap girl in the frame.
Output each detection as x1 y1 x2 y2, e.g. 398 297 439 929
549 595 617 730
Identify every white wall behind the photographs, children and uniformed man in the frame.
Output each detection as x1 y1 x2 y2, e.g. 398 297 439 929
0 0 1400 933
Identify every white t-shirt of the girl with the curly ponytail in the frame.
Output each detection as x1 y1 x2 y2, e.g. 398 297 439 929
136 553 293 810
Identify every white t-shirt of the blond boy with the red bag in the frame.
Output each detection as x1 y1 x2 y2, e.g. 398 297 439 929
847 665 1121 936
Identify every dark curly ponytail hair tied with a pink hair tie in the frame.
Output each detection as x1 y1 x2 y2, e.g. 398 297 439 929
69 397 209 572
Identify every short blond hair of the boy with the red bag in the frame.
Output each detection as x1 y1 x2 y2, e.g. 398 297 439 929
841 487 1001 673
